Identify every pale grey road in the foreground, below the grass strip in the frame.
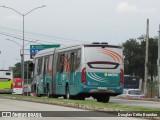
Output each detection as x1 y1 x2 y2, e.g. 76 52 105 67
0 99 144 120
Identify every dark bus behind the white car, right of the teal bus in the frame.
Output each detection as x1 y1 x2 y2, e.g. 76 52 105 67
124 75 140 89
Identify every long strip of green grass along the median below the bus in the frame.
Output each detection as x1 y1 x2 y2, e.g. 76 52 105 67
0 94 160 111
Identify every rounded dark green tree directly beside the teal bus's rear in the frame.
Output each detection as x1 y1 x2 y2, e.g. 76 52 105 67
123 39 144 76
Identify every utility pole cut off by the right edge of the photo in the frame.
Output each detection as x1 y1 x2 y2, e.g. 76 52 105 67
157 25 160 98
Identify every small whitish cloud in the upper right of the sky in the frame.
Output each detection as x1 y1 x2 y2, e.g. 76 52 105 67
116 2 156 13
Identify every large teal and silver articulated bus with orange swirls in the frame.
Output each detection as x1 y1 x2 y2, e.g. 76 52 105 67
29 43 124 102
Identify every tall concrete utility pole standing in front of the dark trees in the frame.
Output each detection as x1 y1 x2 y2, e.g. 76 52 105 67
144 19 149 96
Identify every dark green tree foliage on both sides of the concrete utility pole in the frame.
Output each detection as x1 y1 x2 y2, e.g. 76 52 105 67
123 36 158 80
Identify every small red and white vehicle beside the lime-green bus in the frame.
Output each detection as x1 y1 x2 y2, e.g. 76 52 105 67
12 78 23 94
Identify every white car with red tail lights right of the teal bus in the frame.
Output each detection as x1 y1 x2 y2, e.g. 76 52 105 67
119 89 145 99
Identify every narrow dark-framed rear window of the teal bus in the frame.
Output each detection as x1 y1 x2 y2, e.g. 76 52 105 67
87 61 119 69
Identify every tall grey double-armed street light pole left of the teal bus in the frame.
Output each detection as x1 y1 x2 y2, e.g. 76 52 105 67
0 5 46 91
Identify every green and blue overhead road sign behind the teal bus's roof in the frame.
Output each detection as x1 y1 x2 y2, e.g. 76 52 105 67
30 44 60 59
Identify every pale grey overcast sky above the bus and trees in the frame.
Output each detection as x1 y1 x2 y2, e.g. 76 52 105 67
0 0 160 69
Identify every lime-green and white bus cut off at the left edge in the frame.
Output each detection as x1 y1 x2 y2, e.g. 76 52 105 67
0 70 13 93
